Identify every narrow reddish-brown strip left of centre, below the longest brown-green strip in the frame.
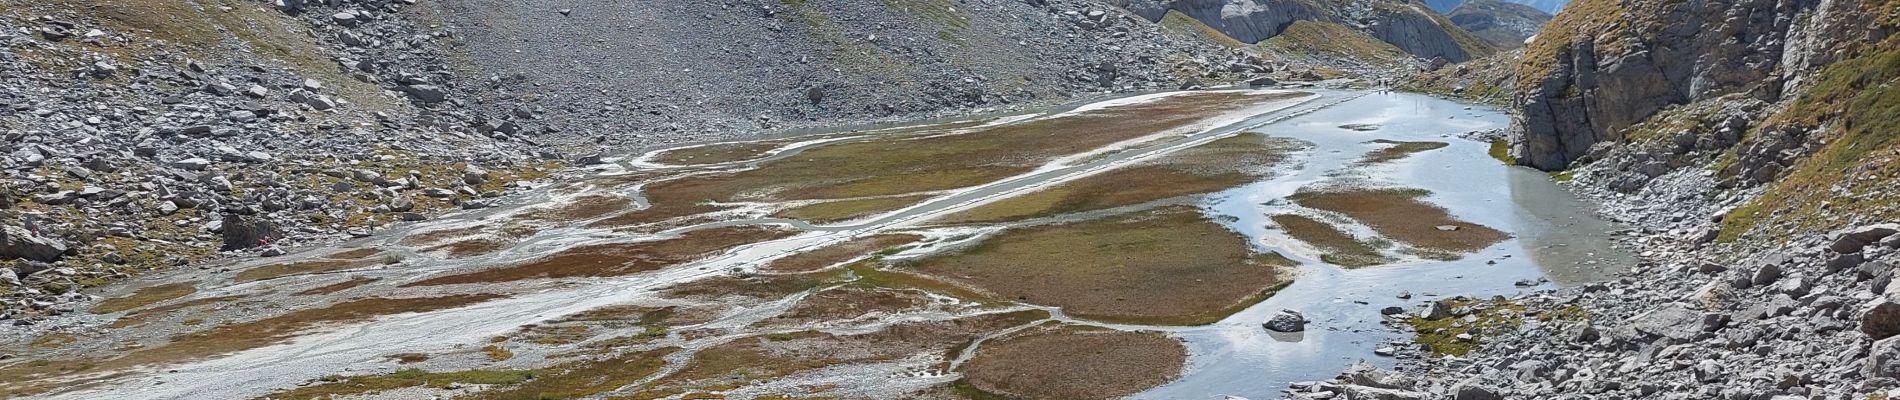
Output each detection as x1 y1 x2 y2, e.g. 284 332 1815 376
403 226 796 286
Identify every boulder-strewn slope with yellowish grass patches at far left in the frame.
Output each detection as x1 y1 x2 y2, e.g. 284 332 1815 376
0 0 585 324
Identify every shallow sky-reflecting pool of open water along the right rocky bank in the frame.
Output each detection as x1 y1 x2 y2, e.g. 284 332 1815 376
1136 93 1632 398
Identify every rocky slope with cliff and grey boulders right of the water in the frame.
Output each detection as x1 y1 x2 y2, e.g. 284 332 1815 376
1294 0 1900 398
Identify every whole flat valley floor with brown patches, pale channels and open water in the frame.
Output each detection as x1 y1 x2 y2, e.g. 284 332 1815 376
0 91 1623 398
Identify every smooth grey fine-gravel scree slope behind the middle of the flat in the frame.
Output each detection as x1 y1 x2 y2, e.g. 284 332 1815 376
420 0 1273 148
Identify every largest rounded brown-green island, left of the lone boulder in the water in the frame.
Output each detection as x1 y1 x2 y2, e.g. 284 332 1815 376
904 207 1283 324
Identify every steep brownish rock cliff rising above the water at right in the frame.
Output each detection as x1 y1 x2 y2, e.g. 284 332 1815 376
1516 0 1841 169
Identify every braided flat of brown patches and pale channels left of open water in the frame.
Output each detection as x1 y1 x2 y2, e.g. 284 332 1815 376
0 91 1321 398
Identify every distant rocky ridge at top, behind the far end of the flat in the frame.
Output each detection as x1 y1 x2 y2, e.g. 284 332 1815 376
1119 0 1495 63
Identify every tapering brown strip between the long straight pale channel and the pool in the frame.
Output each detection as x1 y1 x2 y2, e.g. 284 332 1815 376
942 133 1300 224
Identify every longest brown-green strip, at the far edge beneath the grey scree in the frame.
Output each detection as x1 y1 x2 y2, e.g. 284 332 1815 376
595 93 1294 227
